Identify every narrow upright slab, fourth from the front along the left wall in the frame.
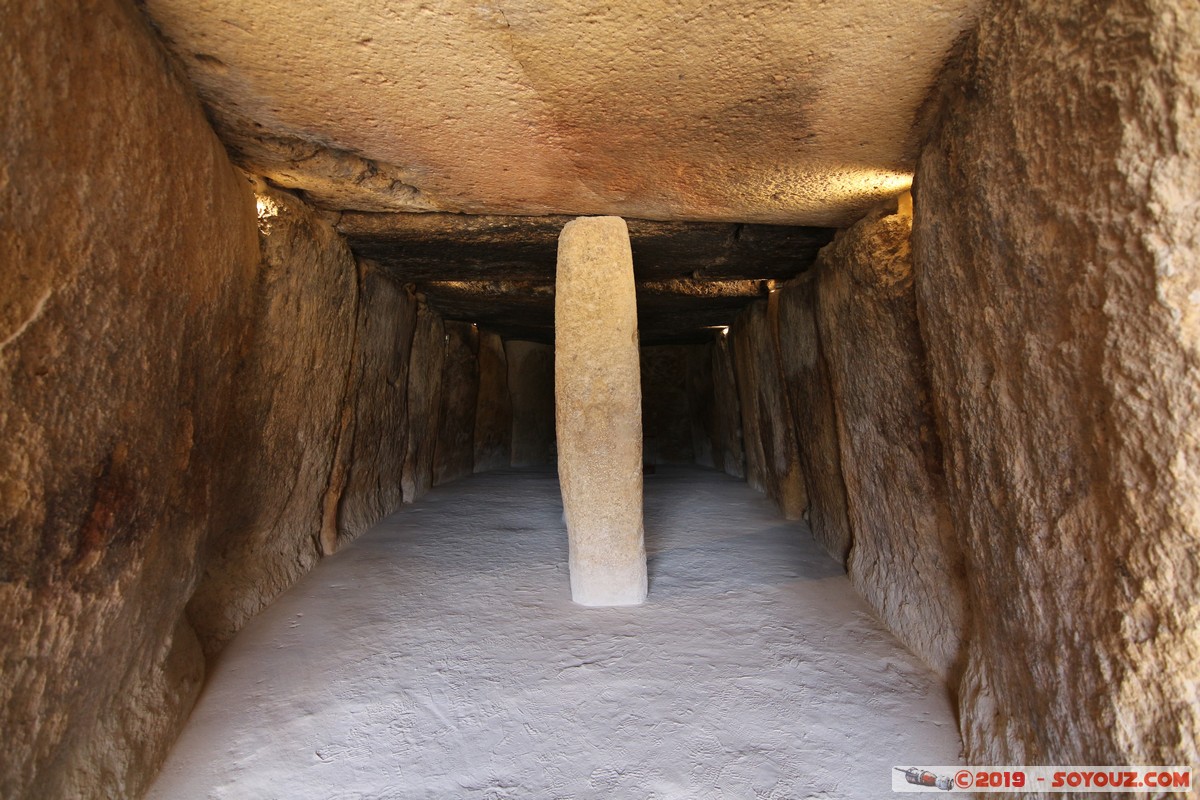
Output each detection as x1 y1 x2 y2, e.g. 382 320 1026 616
401 302 446 503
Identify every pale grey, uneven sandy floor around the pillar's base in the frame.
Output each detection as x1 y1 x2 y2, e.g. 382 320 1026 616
150 469 960 800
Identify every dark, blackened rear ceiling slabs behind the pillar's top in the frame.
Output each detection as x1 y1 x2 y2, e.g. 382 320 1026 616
338 212 833 344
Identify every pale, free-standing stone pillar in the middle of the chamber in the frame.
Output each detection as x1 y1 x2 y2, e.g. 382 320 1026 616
554 217 646 606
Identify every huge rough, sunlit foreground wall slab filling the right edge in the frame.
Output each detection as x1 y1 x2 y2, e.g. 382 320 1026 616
913 0 1200 764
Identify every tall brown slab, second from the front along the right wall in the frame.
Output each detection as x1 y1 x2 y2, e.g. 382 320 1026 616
816 210 964 681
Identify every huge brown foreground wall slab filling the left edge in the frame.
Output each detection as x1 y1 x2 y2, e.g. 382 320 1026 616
0 0 259 800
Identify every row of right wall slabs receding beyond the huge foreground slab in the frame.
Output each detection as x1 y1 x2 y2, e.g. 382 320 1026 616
730 204 968 686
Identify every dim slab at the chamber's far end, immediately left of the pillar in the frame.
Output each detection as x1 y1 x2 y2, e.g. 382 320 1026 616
504 339 554 467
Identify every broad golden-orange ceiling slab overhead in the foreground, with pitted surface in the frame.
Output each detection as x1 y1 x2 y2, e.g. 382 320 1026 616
144 0 980 225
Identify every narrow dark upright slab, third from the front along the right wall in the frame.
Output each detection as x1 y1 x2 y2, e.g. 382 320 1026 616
779 275 852 565
